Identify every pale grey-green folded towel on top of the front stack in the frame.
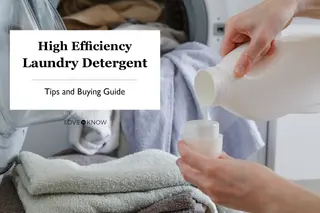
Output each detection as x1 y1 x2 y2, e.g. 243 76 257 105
14 150 217 213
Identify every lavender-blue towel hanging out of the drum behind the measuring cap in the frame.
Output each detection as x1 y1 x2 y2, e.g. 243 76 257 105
119 42 264 159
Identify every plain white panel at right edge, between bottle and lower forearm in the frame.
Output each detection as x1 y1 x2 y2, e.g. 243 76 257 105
274 114 320 180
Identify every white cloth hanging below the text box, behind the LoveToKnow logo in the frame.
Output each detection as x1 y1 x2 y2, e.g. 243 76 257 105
68 110 120 155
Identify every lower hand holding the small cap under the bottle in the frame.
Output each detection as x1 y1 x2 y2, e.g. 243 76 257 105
177 141 296 213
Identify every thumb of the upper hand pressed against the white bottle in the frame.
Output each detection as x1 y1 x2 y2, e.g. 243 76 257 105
235 36 270 78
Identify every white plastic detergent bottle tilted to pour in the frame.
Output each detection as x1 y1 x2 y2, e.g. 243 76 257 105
194 34 320 121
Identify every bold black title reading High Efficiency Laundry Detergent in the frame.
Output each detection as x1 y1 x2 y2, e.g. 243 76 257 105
22 41 148 70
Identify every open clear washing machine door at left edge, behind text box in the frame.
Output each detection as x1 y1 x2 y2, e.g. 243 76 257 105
0 0 72 137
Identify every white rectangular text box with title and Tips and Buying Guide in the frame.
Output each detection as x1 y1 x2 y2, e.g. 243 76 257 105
10 30 160 110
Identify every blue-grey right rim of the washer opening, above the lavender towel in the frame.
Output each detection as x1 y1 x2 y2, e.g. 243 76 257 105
183 0 209 44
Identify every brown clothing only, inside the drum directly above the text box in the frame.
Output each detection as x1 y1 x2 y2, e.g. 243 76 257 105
58 0 162 30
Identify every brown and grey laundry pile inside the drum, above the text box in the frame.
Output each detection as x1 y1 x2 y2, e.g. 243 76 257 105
58 0 187 54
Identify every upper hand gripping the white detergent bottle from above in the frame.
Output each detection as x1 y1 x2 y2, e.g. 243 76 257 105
221 0 300 78
